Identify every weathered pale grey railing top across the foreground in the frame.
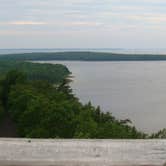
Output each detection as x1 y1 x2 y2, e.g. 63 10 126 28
0 138 166 166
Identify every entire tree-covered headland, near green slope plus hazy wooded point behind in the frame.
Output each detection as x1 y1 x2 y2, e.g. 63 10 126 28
0 60 165 139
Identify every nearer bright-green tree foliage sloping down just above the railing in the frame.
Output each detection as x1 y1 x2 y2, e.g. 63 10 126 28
0 70 146 138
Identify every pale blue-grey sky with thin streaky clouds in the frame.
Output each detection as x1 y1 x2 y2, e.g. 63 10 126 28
0 0 166 49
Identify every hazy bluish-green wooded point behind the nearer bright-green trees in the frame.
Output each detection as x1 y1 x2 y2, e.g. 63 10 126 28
0 60 70 83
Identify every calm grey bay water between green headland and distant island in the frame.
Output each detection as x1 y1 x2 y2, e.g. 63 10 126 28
37 61 166 133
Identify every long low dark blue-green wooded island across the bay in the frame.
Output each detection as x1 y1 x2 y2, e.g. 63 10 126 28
0 52 166 61
